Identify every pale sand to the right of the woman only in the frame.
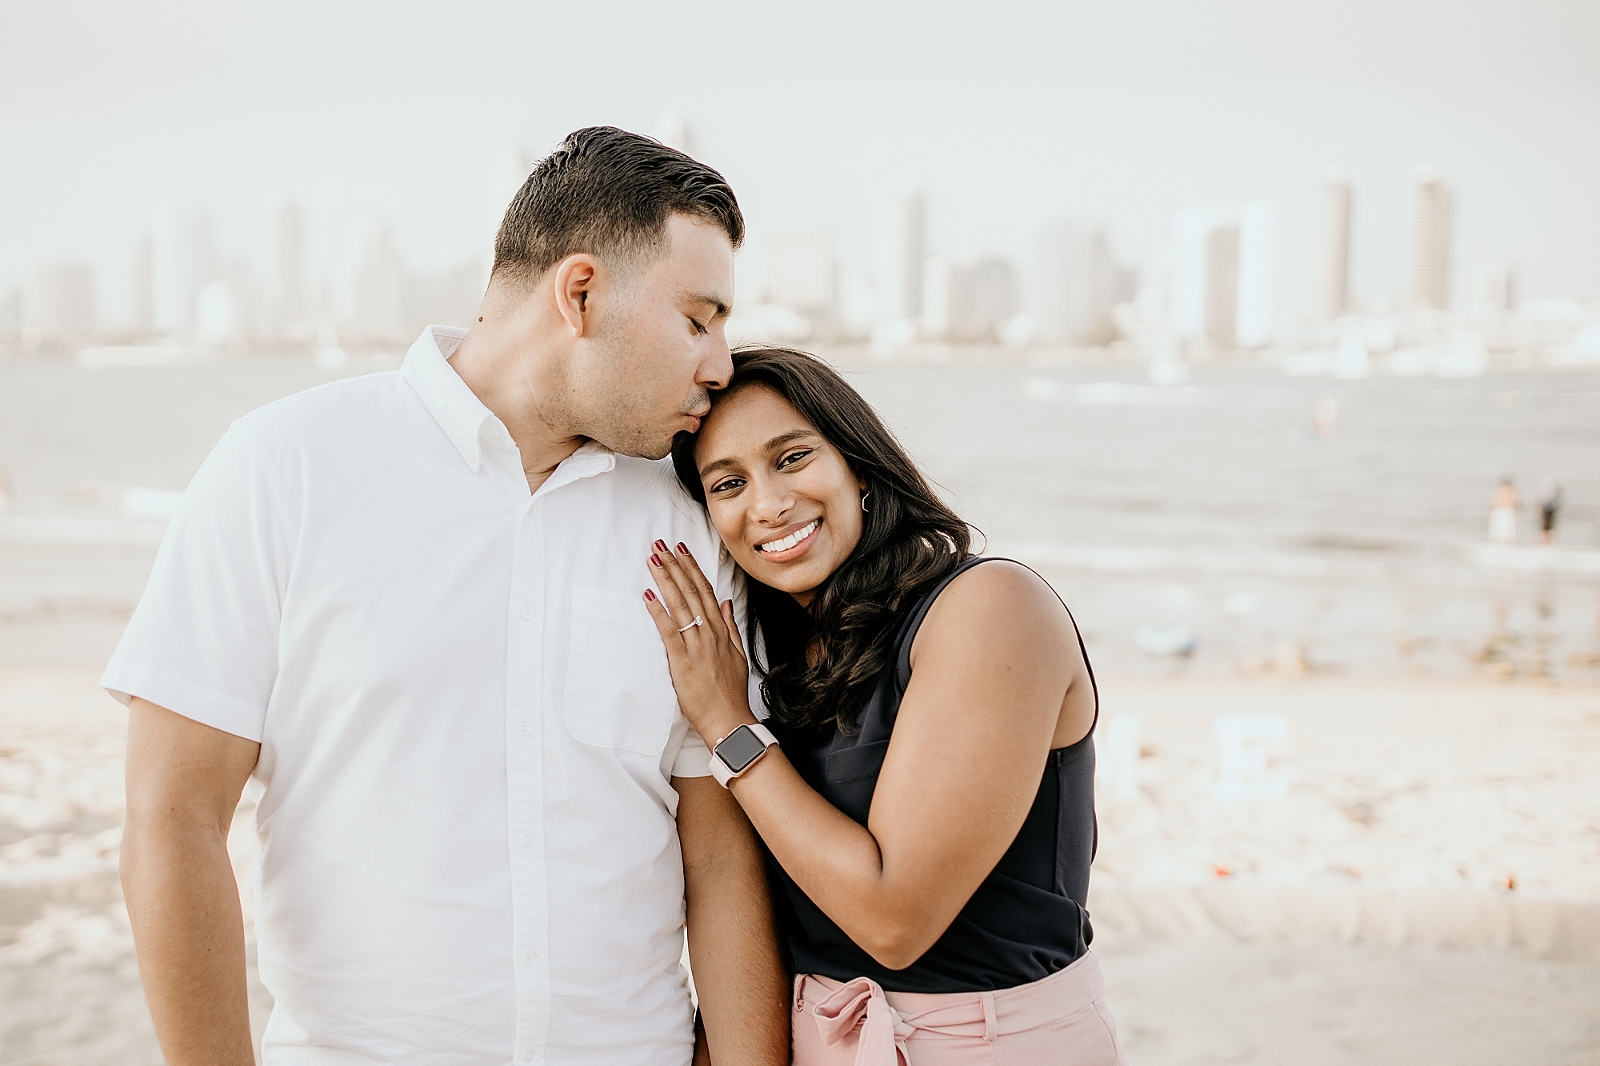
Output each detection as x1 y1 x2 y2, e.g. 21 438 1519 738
1090 679 1600 1066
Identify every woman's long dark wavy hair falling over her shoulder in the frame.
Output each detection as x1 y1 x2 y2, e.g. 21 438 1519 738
672 347 971 733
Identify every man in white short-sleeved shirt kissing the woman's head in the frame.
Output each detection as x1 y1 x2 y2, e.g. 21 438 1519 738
102 128 789 1066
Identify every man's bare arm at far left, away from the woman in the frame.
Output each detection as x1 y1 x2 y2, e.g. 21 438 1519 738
122 698 261 1066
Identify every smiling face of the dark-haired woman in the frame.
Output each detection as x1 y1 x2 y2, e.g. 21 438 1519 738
694 384 862 607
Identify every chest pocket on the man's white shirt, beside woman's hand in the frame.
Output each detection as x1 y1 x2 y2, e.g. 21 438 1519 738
562 586 678 755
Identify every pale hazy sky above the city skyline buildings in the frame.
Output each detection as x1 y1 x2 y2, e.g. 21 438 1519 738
0 3 1600 337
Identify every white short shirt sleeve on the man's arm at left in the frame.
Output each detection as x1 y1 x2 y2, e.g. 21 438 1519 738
101 423 291 741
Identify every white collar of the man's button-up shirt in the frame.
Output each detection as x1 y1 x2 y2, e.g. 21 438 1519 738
400 325 616 493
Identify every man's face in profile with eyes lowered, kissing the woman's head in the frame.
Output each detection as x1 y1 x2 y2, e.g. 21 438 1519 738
571 214 733 459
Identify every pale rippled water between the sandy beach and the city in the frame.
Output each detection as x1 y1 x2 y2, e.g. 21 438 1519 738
0 355 1600 682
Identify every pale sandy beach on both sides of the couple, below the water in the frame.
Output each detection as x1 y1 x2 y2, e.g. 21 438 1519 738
0 667 1600 1066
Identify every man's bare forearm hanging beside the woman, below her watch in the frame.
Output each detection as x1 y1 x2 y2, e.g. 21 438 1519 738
672 778 789 1066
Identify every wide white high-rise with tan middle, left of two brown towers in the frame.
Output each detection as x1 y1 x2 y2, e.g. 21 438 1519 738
1171 203 1278 351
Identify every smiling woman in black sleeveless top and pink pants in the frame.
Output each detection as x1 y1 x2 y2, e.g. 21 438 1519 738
645 349 1122 1066
